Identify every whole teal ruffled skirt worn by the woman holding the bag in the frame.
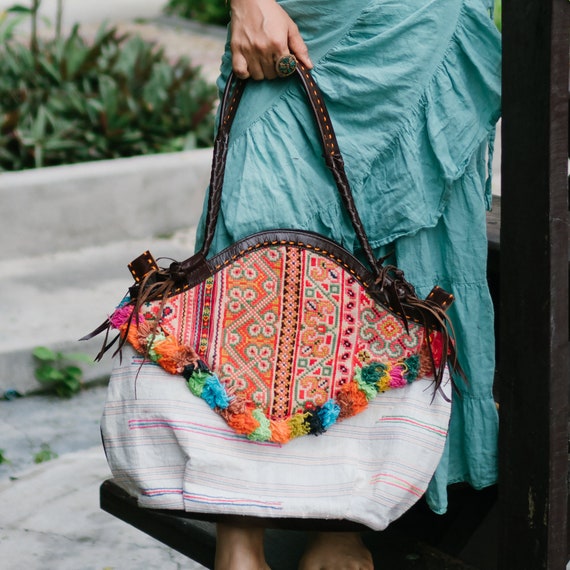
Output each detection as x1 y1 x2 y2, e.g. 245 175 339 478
198 0 500 512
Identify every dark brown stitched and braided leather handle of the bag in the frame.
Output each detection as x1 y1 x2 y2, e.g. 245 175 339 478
199 63 383 276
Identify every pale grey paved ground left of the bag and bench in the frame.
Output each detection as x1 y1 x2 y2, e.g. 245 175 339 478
0 386 202 570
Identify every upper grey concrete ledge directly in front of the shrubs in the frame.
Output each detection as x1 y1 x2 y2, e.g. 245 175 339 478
0 149 212 261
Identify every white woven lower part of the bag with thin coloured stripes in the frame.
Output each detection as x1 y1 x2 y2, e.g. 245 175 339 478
102 348 450 530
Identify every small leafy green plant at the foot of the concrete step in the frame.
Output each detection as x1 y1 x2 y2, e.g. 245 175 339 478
32 346 93 398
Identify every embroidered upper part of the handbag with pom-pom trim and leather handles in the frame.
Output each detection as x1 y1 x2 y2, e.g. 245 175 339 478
84 65 459 443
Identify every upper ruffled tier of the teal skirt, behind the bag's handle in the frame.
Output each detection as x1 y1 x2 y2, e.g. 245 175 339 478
199 0 500 255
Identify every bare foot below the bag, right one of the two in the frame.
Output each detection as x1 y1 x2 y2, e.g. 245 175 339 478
299 532 374 570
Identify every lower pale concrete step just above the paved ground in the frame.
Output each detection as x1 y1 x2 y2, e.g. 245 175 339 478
0 223 203 396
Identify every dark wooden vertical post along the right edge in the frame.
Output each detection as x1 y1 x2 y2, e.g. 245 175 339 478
499 0 570 570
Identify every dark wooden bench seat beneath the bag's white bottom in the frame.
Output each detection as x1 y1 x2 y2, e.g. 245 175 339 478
100 480 496 570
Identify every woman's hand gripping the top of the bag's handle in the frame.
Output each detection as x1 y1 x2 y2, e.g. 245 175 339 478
230 0 313 80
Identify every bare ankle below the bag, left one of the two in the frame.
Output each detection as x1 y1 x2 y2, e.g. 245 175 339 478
214 523 271 570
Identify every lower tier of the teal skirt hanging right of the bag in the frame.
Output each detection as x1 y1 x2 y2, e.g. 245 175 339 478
394 151 498 513
